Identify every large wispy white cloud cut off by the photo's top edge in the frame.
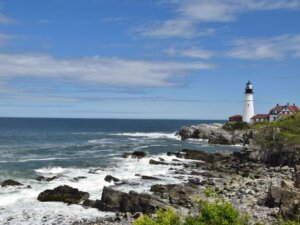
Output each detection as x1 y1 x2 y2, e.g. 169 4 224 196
137 0 300 38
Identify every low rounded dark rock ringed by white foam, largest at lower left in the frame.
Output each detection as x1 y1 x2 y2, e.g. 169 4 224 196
37 185 90 204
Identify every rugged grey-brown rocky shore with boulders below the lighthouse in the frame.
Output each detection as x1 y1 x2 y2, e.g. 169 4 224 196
2 121 300 225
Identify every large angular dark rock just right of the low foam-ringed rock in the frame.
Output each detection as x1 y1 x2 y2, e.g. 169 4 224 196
95 187 166 213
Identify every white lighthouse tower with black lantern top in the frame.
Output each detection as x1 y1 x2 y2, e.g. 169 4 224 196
243 81 254 123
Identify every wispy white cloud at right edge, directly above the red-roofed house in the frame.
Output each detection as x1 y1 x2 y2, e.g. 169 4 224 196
226 35 300 60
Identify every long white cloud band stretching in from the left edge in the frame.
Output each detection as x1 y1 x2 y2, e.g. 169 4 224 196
0 54 214 87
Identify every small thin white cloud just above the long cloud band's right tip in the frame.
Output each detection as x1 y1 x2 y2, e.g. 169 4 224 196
165 48 215 59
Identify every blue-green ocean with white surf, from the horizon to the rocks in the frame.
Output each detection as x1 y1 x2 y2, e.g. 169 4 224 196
0 118 239 225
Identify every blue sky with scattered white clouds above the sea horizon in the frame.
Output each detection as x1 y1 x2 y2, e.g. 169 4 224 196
0 0 300 119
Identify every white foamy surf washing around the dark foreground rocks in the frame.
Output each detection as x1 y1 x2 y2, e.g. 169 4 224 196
0 154 200 225
